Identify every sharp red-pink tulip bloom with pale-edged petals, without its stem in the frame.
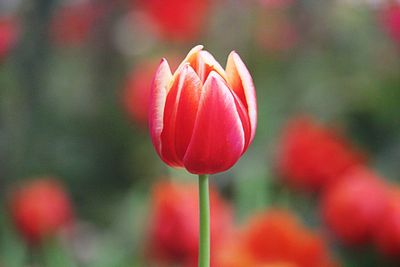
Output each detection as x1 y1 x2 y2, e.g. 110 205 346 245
149 45 257 174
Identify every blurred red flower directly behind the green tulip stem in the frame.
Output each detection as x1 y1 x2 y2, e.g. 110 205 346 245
149 182 233 267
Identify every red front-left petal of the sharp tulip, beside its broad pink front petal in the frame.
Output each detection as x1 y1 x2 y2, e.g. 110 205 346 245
161 63 202 167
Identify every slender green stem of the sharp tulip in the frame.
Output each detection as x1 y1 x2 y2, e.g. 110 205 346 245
199 174 210 267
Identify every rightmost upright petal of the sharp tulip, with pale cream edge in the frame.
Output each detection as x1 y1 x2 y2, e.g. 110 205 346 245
226 51 257 142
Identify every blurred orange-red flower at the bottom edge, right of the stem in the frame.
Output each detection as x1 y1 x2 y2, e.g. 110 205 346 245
217 210 337 267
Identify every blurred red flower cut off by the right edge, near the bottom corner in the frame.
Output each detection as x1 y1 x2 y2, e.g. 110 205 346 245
375 187 400 256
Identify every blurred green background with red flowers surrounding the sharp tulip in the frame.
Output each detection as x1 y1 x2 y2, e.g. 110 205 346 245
0 0 400 267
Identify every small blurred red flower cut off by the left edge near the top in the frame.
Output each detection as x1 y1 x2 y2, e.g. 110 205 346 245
0 17 19 60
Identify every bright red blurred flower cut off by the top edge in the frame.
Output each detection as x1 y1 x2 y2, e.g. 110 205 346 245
139 0 211 41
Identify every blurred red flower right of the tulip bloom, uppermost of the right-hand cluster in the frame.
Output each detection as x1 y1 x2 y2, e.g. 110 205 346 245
277 117 363 191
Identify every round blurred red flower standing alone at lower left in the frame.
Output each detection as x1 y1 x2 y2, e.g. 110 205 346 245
10 179 72 244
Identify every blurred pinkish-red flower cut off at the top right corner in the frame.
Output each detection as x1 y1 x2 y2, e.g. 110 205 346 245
380 3 400 45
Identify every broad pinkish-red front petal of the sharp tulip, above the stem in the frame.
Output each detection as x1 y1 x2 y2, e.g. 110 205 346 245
183 71 245 174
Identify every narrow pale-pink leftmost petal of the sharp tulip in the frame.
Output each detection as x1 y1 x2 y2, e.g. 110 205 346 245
149 59 172 162
